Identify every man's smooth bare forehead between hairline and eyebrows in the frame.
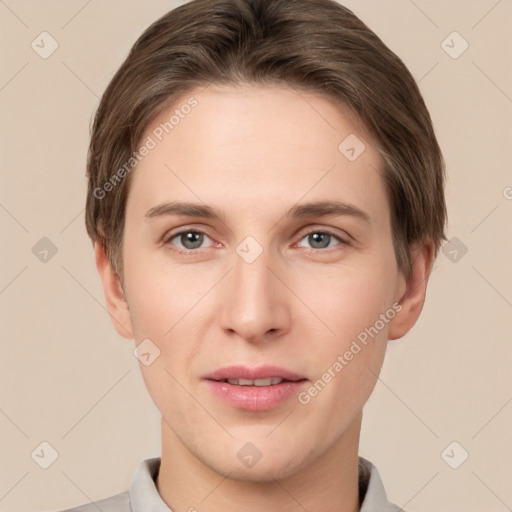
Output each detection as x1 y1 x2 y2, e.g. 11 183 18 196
128 85 388 226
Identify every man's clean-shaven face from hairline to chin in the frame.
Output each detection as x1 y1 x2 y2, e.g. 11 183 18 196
98 86 421 480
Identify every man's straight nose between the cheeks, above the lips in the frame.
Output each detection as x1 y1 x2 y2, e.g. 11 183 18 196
220 244 290 343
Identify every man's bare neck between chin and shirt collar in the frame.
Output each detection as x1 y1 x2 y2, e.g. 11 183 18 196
156 413 362 512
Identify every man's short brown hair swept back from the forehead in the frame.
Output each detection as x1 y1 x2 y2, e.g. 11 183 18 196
85 0 447 279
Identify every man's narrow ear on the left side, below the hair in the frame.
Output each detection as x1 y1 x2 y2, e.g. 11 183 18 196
94 241 134 339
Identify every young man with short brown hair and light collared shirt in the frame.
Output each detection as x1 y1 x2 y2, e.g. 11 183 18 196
59 0 446 512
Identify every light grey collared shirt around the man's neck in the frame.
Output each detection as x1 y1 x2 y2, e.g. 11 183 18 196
58 457 404 512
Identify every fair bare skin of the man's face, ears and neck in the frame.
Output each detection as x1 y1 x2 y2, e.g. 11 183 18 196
95 85 433 512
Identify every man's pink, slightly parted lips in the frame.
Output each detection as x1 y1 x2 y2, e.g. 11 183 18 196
203 365 308 412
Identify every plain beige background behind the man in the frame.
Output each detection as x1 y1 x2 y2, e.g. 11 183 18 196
0 0 512 512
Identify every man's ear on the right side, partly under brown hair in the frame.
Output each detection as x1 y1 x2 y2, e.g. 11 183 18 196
388 241 434 340
